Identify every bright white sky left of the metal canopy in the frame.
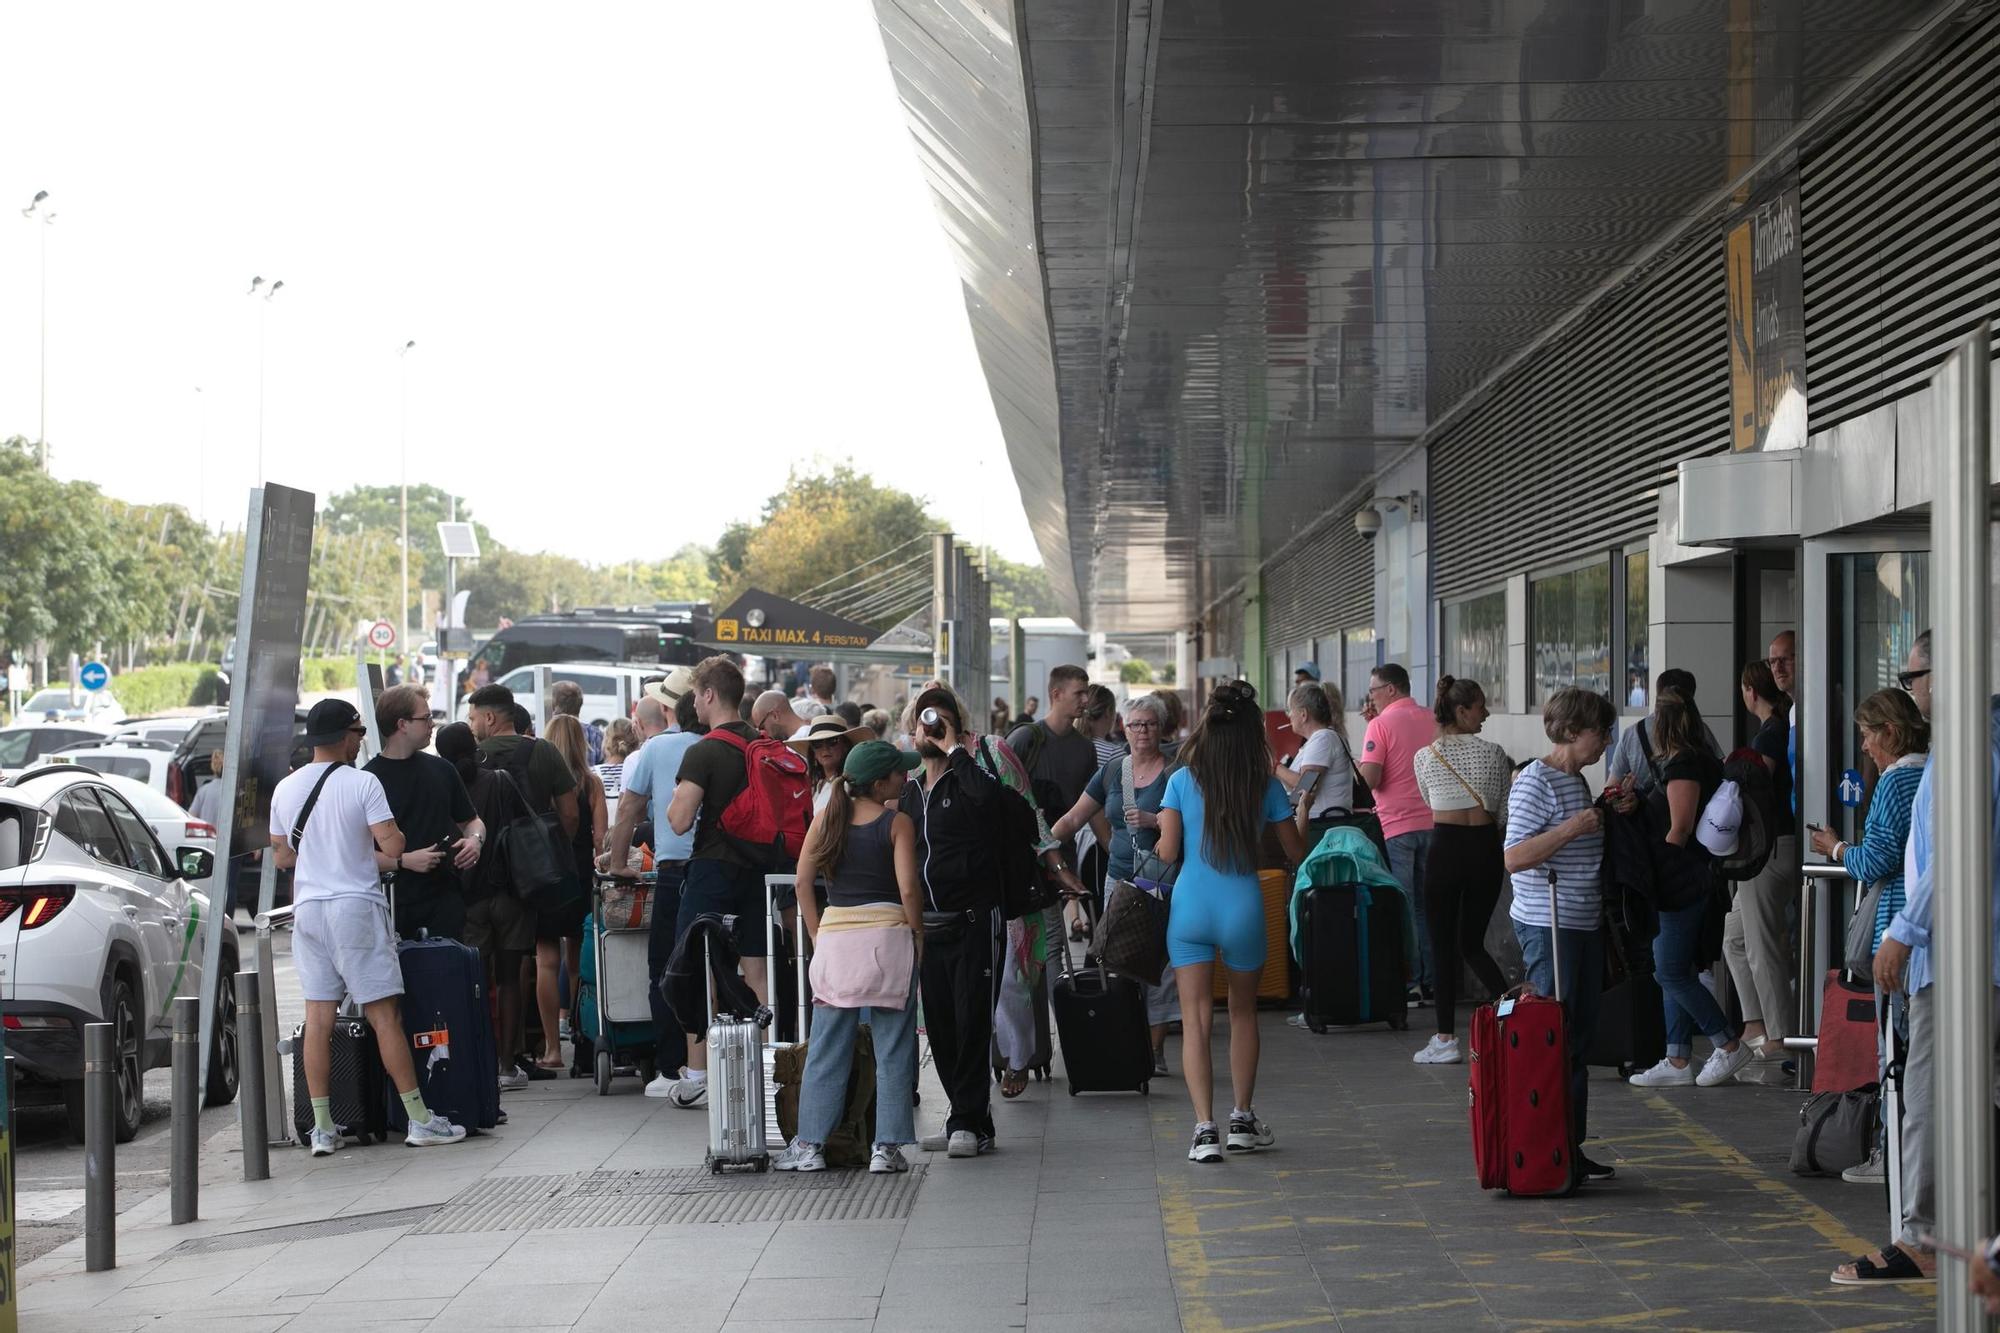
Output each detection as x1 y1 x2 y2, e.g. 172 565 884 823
0 0 1038 562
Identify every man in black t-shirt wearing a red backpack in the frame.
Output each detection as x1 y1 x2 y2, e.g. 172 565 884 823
666 656 770 1109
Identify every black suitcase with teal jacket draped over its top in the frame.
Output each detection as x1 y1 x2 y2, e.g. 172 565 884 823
1298 885 1410 1033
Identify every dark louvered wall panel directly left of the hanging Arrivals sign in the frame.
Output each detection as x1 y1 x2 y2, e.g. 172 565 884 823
1430 234 1730 598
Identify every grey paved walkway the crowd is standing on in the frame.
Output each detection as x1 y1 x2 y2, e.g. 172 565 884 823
11 1013 1932 1333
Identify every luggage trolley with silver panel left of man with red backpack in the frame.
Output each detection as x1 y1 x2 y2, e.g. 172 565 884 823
578 871 660 1097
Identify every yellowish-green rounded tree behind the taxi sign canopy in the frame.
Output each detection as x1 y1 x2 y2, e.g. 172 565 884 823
710 464 942 614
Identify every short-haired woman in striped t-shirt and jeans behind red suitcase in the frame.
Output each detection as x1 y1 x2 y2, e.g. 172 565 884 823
1506 687 1626 1181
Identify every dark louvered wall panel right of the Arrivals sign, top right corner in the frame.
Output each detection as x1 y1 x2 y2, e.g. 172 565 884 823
1798 10 2000 430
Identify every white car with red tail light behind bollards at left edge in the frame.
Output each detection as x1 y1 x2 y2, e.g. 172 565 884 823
0 765 238 1143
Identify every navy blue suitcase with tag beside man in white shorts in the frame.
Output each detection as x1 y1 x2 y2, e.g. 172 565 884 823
388 939 500 1133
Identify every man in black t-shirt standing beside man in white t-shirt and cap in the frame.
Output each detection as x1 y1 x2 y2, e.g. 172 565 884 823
366 685 486 939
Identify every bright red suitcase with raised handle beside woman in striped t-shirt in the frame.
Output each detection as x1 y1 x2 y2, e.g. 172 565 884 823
1470 860 1582 1197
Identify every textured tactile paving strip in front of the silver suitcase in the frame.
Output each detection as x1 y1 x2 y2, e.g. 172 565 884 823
412 1165 924 1235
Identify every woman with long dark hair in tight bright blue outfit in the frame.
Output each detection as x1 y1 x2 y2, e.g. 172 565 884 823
1156 681 1306 1163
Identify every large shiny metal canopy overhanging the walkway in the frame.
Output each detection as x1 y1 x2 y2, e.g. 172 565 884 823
876 0 1928 630
